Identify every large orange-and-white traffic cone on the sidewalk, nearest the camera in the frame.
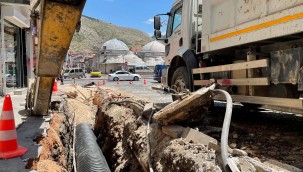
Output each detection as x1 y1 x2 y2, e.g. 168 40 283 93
0 95 27 159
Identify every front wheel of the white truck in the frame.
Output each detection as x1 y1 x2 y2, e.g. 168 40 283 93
171 66 190 92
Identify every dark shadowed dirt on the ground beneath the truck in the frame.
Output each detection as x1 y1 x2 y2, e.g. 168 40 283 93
198 106 303 169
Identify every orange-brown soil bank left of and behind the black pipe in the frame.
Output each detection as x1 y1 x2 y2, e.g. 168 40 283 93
27 85 97 172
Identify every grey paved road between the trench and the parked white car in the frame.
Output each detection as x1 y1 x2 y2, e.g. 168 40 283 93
64 75 172 103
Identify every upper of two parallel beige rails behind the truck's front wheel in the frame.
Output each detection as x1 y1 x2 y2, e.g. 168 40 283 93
193 59 268 74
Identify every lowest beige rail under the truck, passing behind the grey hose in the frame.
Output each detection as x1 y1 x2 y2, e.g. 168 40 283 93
214 94 303 109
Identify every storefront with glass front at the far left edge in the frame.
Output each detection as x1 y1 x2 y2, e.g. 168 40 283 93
0 3 31 95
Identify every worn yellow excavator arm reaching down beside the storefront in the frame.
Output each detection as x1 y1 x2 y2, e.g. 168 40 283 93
27 0 86 115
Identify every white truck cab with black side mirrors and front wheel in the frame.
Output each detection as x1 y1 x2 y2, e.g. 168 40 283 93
154 0 202 91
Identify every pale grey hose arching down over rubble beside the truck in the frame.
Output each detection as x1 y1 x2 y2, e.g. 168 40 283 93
215 89 240 171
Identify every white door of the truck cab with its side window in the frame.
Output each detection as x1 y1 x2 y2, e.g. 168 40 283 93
165 4 183 64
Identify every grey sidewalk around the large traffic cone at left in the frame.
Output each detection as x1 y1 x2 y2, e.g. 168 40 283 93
0 89 49 172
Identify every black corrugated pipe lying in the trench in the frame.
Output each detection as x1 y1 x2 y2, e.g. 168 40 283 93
75 123 110 172
